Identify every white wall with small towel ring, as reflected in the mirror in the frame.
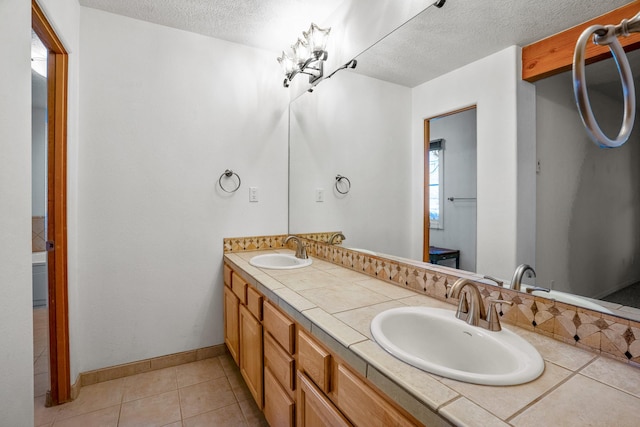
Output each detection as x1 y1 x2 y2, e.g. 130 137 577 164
289 71 413 256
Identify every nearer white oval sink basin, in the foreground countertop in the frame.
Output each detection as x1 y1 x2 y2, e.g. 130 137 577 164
371 307 544 385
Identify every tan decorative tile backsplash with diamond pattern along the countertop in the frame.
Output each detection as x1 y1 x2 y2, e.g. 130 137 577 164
224 233 640 367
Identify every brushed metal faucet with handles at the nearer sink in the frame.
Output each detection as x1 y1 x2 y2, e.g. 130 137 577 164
449 278 513 331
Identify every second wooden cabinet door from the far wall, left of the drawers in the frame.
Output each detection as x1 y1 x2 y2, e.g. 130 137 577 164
240 305 263 409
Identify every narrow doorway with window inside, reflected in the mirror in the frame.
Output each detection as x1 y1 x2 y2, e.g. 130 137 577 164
423 106 477 271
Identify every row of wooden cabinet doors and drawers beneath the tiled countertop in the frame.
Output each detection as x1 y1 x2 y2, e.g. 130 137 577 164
224 265 419 427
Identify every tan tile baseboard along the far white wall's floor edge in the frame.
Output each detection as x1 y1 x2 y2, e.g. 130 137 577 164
71 344 228 399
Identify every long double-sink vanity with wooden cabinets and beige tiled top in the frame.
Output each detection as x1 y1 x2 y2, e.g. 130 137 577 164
224 236 640 426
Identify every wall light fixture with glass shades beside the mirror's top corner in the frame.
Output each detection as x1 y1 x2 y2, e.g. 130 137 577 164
278 23 331 87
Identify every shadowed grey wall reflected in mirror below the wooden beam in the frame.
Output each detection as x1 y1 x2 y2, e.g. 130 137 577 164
536 70 640 298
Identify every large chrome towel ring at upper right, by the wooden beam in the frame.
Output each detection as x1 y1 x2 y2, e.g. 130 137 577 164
573 13 640 148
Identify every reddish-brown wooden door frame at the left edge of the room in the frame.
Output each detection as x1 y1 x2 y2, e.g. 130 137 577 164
31 0 71 406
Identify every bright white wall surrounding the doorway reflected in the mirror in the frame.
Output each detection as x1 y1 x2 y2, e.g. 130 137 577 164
412 46 535 278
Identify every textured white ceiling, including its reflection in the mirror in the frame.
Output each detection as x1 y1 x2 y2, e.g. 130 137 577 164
79 0 630 87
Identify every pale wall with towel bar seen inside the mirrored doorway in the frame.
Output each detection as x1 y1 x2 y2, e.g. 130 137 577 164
429 109 477 271
